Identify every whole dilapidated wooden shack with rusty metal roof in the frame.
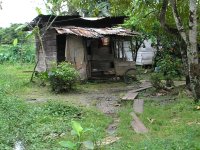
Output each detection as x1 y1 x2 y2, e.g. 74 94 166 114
29 15 138 79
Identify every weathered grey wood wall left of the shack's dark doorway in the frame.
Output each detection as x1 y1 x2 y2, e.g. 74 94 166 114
36 30 57 72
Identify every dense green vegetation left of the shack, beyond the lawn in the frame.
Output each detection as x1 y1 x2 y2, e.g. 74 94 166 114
0 24 35 63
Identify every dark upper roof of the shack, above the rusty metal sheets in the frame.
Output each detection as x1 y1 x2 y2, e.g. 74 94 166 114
24 15 127 31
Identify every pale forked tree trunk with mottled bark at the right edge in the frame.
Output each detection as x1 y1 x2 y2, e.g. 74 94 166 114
170 0 200 101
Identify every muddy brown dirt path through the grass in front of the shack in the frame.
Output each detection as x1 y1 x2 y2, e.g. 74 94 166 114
26 82 152 137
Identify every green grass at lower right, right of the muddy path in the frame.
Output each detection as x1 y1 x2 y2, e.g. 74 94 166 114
111 95 200 150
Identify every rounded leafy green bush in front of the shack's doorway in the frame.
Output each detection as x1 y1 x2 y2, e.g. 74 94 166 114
49 62 79 92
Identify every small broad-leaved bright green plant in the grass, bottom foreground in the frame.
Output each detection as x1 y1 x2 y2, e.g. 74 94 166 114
59 121 95 150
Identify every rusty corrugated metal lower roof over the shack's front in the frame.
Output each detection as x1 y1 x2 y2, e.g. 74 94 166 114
54 26 140 38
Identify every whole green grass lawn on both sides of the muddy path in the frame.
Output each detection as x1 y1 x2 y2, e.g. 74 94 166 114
0 64 200 150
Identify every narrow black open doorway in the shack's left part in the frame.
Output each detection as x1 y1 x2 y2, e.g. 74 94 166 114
56 34 66 63
